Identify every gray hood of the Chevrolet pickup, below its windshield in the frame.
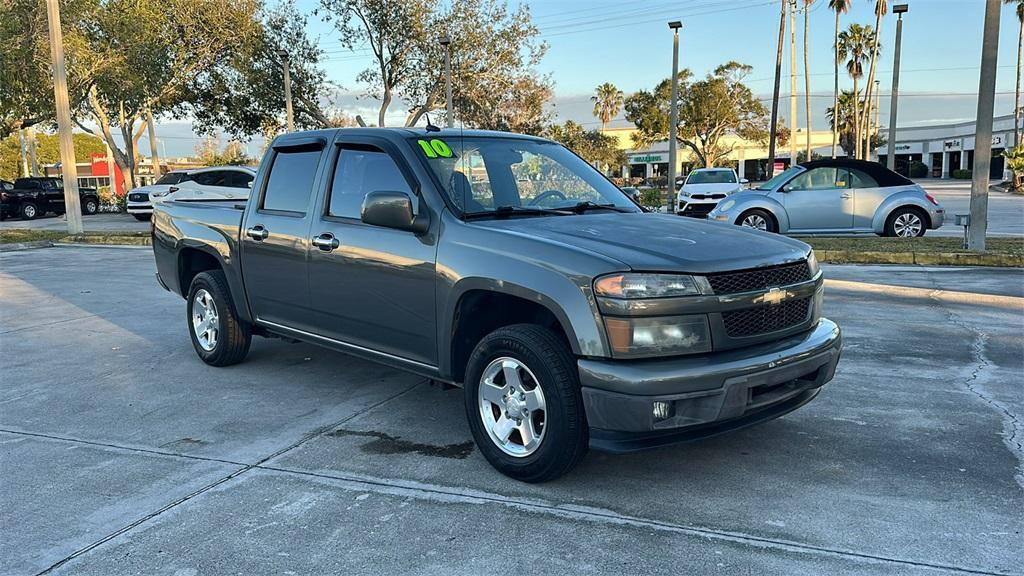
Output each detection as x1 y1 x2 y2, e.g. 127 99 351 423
473 212 810 274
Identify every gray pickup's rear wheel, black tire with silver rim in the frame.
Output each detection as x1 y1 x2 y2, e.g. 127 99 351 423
185 270 252 366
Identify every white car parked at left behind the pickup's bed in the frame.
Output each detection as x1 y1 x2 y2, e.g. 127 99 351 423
128 166 256 220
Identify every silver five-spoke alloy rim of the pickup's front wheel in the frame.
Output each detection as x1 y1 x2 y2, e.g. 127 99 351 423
477 357 547 458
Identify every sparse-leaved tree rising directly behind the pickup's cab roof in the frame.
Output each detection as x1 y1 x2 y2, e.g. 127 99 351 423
321 0 551 132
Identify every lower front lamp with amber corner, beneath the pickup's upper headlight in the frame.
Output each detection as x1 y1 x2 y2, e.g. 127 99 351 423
604 315 711 358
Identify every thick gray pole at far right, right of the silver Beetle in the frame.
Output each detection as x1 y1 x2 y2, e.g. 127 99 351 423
967 0 1001 252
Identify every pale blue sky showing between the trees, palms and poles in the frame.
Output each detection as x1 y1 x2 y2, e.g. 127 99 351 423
151 0 1019 155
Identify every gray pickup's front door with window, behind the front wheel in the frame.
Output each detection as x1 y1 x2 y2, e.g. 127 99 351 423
309 133 437 366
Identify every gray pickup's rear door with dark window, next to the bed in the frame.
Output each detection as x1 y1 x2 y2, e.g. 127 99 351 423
241 137 325 332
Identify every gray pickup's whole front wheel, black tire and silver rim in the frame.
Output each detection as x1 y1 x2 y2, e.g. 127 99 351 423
465 324 590 483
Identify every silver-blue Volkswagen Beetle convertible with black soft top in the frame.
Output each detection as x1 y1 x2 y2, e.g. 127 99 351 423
708 159 945 238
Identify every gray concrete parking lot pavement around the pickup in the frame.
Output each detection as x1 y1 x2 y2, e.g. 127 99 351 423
0 247 1024 576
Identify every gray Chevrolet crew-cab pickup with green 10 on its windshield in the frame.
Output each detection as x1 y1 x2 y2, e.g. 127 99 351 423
153 128 842 482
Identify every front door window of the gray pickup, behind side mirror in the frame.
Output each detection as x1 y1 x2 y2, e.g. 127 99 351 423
328 149 416 218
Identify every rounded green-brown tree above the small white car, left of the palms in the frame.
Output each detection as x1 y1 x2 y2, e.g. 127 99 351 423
625 61 768 168
